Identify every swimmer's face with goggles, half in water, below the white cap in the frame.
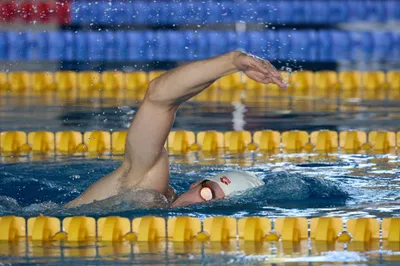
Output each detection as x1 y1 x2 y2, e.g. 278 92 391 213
172 180 225 207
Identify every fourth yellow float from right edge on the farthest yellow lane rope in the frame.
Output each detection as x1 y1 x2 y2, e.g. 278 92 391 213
314 71 340 97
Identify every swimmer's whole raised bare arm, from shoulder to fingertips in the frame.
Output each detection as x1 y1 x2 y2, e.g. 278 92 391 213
66 52 285 207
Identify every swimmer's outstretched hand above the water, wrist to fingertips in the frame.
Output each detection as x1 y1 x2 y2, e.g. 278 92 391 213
234 52 287 89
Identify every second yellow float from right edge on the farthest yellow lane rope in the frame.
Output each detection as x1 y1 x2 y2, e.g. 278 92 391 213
362 71 388 100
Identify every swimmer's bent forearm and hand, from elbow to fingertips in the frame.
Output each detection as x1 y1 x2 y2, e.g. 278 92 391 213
148 52 285 107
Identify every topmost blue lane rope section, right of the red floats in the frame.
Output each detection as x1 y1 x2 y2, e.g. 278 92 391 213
71 0 400 26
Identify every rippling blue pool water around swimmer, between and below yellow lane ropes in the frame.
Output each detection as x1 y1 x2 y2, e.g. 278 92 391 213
0 96 400 265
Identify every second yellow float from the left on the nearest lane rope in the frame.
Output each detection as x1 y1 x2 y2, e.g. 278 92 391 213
28 216 61 241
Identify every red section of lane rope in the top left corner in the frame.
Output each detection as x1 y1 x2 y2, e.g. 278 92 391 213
0 0 71 24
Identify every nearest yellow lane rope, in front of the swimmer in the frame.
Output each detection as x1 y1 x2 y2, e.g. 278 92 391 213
0 216 400 246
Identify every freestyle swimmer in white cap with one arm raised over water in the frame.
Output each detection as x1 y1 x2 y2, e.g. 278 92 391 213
66 51 286 207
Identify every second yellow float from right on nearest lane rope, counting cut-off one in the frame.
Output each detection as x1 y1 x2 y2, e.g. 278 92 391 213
346 218 380 242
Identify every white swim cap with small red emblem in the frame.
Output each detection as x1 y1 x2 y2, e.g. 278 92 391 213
204 171 264 196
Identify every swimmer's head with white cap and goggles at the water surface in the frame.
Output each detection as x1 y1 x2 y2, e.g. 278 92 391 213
172 171 264 207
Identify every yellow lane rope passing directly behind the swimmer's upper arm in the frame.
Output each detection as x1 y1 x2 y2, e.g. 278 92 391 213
0 130 400 155
